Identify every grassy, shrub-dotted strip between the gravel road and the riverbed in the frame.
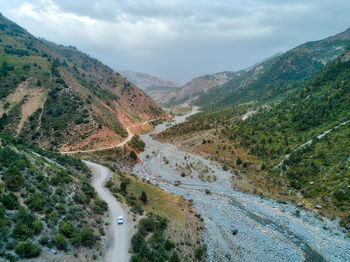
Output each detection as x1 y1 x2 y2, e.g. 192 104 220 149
106 169 205 261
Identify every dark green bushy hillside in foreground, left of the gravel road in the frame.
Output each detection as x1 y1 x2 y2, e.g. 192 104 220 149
0 138 107 261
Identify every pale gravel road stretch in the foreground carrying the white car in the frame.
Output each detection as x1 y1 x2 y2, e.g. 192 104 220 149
84 161 131 262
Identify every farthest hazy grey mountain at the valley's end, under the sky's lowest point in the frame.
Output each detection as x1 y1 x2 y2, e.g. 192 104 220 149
119 70 180 104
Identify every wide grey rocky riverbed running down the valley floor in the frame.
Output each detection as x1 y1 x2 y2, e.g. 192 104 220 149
133 109 350 261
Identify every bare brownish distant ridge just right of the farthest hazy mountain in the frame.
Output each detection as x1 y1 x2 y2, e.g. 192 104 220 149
162 71 239 105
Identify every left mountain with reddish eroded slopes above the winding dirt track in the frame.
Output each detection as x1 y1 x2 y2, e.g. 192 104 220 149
0 15 163 151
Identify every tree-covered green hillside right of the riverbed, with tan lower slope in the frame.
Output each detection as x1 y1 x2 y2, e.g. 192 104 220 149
159 52 350 225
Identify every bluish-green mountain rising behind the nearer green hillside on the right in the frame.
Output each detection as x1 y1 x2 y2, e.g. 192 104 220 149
197 28 350 108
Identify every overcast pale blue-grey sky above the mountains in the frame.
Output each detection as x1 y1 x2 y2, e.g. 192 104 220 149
0 0 350 83
